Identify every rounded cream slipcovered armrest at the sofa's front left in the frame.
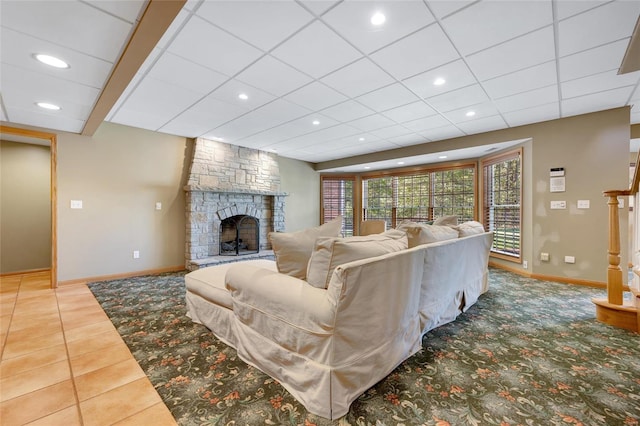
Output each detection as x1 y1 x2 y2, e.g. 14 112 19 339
225 264 335 335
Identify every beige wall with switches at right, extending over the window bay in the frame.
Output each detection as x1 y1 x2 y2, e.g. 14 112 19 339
316 107 630 283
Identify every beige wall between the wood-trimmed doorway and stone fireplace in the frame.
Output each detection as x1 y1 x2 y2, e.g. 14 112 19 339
58 123 192 281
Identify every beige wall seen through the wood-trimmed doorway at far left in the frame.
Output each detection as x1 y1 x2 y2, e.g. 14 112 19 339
0 141 51 273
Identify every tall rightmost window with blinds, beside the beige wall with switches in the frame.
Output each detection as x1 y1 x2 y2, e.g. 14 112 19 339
482 150 522 261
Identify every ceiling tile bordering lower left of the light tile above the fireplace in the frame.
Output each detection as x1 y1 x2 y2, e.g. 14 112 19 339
160 95 248 138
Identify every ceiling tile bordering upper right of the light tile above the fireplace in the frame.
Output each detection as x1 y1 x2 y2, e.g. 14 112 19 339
236 55 312 96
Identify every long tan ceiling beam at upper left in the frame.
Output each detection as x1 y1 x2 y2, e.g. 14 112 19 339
82 0 186 136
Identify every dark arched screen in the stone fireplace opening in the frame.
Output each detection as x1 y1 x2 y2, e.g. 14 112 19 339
220 215 260 256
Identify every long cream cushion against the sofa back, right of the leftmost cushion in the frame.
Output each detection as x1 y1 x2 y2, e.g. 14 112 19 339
307 229 408 288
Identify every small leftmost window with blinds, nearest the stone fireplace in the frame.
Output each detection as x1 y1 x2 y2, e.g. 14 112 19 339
320 176 355 237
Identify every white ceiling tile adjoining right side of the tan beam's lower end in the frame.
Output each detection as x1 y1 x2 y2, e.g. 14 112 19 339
113 77 201 130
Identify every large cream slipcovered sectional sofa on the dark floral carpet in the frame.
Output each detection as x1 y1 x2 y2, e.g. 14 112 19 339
185 220 492 419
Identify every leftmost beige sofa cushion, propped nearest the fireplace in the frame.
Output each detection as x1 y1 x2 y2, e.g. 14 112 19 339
268 216 342 280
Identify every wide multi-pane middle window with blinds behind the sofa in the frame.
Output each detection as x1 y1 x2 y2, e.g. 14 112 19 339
362 165 476 227
